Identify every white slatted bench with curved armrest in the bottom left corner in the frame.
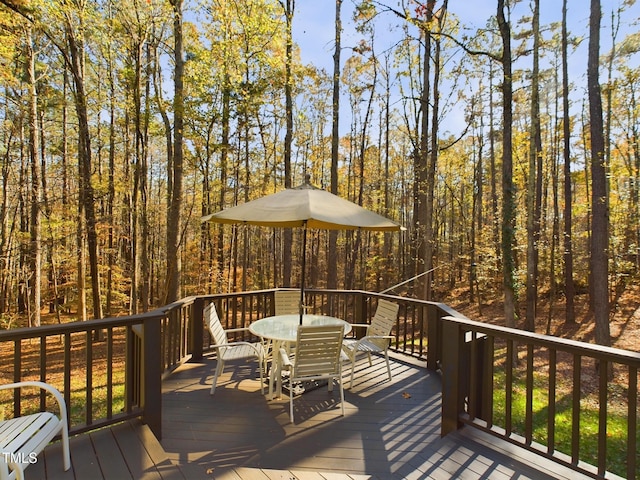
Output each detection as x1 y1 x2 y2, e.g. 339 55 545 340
0 381 71 480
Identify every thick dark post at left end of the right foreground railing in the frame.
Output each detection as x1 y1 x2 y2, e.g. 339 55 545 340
440 318 464 437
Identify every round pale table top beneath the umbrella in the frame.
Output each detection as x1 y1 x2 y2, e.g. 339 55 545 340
249 313 351 342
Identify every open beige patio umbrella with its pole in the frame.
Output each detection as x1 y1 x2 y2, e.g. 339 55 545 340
201 183 404 322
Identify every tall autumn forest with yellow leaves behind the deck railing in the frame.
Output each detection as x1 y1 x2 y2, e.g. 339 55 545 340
0 0 640 345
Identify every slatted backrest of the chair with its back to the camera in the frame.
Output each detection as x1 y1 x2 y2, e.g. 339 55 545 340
292 325 344 378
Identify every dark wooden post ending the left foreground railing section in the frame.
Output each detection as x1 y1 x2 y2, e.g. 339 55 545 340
142 317 162 440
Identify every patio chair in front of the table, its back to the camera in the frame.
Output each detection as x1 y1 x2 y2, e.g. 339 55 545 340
280 326 344 423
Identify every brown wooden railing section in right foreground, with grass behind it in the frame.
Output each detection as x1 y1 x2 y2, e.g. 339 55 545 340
441 317 640 479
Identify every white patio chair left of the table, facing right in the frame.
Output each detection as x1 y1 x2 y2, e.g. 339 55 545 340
203 303 265 395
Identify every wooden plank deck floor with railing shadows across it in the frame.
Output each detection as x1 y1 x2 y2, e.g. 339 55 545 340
36 350 596 480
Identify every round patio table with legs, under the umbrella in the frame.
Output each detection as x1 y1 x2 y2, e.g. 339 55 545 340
249 313 351 400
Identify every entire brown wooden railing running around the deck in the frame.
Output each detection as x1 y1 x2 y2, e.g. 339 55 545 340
0 289 640 479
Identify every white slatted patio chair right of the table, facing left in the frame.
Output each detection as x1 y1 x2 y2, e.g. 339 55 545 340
342 299 400 388
